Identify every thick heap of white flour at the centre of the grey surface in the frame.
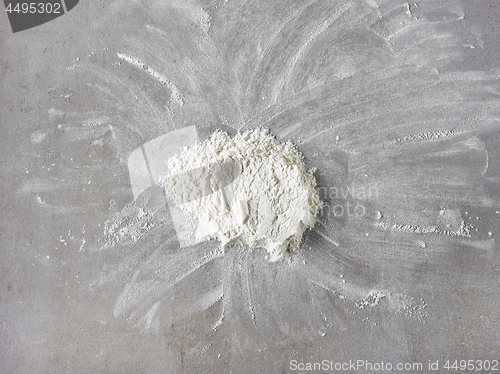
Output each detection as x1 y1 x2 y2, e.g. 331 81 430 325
160 129 321 261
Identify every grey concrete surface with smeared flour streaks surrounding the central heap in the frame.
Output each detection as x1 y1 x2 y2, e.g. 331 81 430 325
0 0 500 373
